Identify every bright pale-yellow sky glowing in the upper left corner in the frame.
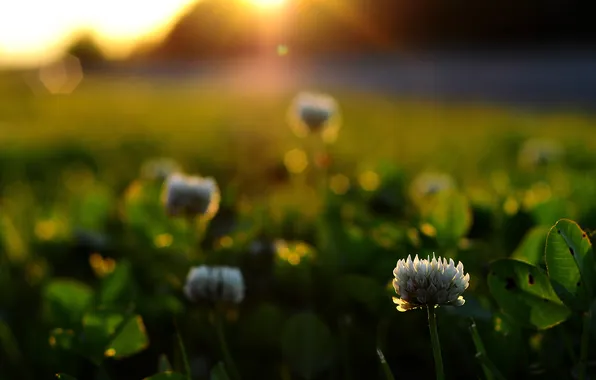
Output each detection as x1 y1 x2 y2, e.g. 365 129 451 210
0 0 200 67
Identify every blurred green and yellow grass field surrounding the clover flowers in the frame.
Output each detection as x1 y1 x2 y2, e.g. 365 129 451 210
0 74 596 380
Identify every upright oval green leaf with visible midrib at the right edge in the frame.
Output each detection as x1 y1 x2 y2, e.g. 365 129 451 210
545 219 596 311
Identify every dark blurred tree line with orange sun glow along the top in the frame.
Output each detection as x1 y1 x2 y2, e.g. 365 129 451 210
66 0 596 61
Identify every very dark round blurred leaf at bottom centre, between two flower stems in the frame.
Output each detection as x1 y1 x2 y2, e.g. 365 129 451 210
281 312 333 379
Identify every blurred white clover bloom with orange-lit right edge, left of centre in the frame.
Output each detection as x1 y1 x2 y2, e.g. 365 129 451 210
163 173 221 219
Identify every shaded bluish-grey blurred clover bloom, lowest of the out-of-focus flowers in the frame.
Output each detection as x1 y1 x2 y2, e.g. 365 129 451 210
184 265 245 304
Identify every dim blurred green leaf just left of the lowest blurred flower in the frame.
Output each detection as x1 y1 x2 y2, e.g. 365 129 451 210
98 260 134 306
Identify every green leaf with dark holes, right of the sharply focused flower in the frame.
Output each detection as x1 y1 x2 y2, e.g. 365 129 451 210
488 259 571 330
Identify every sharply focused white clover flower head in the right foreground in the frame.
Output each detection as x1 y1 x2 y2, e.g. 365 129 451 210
393 253 470 311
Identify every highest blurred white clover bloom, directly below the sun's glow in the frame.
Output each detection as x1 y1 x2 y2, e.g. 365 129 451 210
290 92 340 142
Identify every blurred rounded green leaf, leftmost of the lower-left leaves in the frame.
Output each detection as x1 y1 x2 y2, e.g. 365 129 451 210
44 279 93 328
